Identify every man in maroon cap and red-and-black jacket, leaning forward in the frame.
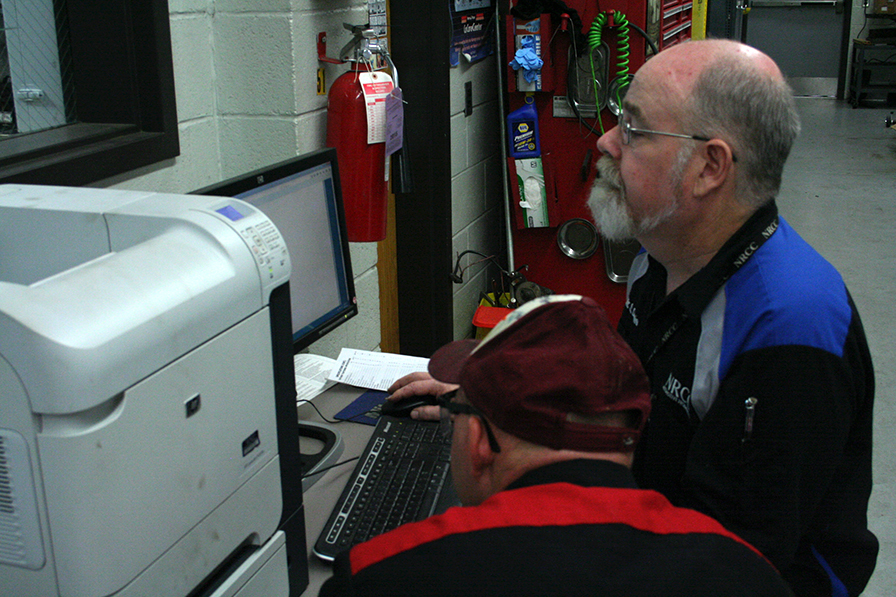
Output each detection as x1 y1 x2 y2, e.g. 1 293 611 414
321 295 790 596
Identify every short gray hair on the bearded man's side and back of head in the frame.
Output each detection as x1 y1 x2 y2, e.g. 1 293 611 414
684 55 800 209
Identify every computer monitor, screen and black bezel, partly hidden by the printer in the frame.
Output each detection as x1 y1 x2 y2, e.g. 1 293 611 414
194 149 358 352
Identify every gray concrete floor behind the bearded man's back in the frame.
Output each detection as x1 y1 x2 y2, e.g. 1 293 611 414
778 97 896 597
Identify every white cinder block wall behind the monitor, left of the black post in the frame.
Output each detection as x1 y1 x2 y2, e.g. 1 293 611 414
96 0 380 357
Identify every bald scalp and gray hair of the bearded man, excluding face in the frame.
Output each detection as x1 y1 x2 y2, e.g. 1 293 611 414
632 39 800 208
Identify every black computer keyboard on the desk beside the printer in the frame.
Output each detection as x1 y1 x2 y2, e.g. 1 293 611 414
314 416 458 560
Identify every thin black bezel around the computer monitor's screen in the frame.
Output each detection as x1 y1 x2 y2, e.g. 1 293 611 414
192 147 358 354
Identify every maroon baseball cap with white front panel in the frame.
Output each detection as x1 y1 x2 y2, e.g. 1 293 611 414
429 295 650 452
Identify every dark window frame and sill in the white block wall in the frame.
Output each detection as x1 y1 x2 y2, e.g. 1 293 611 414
0 0 180 186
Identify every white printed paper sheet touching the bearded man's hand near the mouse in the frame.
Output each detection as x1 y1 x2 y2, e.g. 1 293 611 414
330 348 429 391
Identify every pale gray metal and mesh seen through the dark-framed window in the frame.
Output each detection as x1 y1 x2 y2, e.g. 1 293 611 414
0 0 76 135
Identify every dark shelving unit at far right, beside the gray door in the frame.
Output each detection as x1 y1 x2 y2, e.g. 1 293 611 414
849 40 896 108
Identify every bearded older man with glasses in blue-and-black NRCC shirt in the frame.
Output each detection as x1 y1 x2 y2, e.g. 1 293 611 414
589 40 878 595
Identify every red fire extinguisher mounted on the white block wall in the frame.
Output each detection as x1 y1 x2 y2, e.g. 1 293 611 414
327 26 387 242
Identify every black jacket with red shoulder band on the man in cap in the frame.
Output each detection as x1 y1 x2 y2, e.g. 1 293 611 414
320 460 790 596
